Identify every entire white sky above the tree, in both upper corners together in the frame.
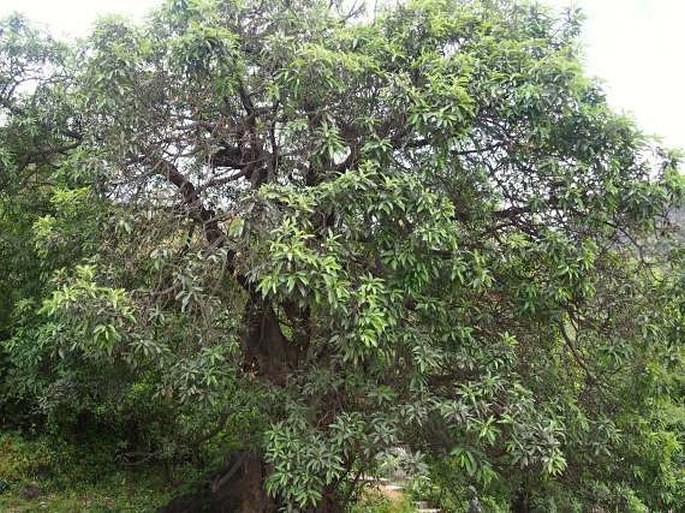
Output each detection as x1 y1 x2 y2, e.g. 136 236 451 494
0 0 685 149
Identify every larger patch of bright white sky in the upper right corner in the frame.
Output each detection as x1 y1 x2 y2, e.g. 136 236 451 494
546 0 685 149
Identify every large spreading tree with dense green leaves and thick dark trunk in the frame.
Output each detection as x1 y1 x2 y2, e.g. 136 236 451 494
0 0 683 512
